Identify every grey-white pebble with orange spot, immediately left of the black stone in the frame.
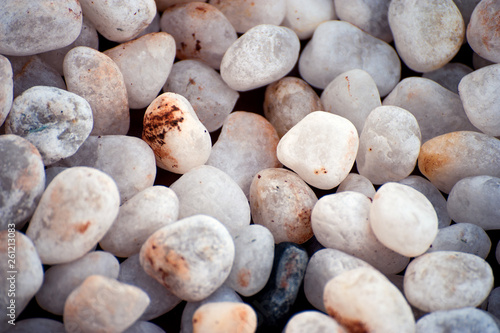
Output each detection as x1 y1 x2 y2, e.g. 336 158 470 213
225 224 274 296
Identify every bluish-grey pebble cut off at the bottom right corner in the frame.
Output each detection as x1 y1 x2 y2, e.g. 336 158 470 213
415 307 500 333
